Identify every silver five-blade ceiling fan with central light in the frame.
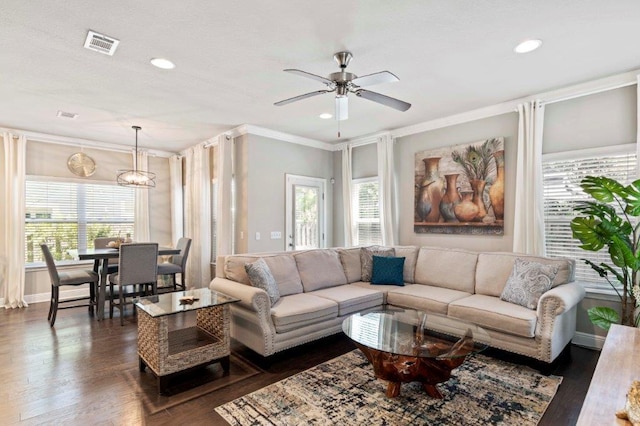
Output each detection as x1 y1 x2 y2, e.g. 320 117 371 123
274 52 411 120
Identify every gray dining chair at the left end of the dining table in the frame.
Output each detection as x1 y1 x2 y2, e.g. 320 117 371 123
40 244 100 327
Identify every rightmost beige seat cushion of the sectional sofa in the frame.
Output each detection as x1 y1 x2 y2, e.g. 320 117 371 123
448 294 538 337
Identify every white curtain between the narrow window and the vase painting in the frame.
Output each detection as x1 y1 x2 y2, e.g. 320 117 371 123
378 135 398 246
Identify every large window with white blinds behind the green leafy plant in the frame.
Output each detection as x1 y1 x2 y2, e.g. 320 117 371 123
542 144 637 288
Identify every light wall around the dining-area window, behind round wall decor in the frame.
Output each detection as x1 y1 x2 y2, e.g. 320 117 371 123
25 141 172 295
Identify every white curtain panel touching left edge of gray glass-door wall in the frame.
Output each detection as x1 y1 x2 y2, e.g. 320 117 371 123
216 135 234 256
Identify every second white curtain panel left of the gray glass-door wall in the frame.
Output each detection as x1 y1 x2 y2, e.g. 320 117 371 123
184 145 211 288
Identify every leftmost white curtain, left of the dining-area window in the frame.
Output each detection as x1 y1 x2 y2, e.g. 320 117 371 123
0 132 28 308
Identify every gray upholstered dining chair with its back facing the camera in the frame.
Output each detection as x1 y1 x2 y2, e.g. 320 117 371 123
109 243 158 325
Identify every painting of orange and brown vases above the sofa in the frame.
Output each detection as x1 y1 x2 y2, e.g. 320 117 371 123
414 137 505 235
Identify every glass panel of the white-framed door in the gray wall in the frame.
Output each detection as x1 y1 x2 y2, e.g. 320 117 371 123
293 185 320 250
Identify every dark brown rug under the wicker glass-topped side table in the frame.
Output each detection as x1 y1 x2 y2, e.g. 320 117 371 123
124 354 263 414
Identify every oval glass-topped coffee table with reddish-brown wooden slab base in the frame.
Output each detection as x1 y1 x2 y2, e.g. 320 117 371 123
342 309 490 398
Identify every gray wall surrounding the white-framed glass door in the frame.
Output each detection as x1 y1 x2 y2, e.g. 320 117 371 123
236 135 334 253
